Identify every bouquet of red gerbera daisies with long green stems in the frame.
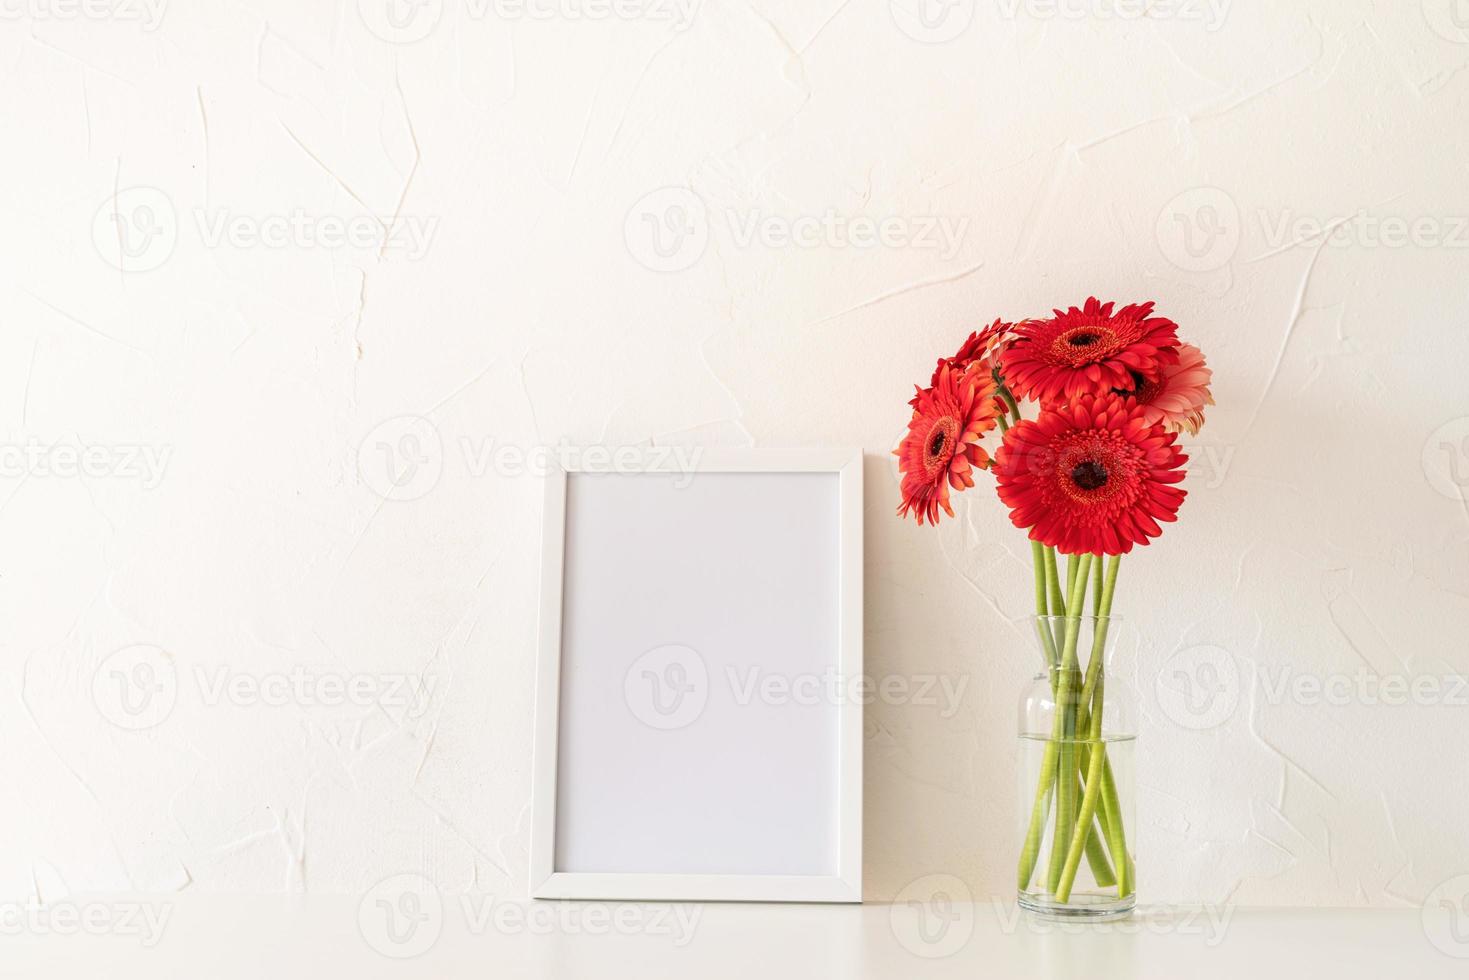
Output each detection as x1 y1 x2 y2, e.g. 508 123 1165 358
896 298 1213 905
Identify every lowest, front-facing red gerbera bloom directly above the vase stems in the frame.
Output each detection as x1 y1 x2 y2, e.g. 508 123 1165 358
993 394 1188 555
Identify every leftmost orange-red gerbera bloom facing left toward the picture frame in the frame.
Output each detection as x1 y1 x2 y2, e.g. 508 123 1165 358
893 361 1000 525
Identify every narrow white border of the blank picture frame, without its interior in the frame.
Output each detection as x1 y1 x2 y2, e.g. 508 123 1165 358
530 448 862 902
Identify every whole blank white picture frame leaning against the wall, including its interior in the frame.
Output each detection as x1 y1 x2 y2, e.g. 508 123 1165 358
530 450 862 902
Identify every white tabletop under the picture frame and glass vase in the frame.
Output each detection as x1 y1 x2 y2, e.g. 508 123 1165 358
0 893 1469 980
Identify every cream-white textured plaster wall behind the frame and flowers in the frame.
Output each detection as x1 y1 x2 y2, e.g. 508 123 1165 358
0 0 1469 905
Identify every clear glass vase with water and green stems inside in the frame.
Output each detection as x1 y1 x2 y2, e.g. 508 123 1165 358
1017 616 1137 918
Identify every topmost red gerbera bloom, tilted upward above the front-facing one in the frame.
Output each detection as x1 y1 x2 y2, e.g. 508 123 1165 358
1000 297 1178 404
